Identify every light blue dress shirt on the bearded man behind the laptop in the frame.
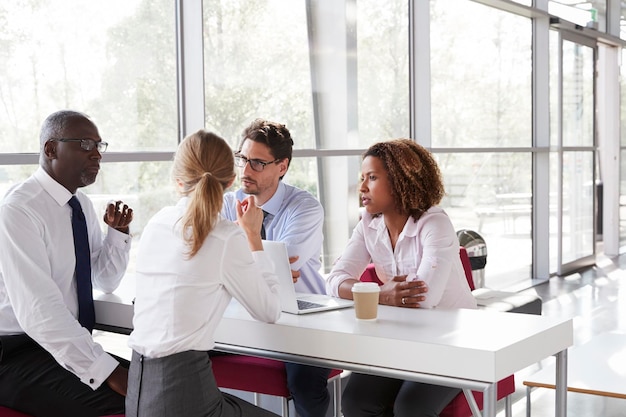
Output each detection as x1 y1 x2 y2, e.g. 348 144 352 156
222 181 326 294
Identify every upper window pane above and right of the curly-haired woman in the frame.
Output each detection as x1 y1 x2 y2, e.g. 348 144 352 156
431 0 532 147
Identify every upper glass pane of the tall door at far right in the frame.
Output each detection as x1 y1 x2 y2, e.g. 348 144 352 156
562 40 594 146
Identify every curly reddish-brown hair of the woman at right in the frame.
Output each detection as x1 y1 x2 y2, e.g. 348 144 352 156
363 139 445 220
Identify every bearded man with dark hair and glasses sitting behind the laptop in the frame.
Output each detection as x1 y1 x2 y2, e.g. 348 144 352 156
222 119 330 417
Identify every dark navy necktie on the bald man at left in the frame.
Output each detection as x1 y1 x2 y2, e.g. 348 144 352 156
69 196 96 332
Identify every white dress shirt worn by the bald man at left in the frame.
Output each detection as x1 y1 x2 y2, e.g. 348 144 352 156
0 168 131 389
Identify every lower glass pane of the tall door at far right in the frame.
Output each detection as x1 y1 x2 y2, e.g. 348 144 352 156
562 152 595 264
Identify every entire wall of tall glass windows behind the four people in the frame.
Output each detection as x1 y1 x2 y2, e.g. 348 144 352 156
0 0 626 288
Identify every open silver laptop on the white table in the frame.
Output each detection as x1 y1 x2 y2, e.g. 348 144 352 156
263 240 354 314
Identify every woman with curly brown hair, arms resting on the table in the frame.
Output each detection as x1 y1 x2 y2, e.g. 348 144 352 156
327 139 476 417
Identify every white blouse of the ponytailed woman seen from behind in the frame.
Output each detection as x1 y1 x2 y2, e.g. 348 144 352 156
128 197 281 358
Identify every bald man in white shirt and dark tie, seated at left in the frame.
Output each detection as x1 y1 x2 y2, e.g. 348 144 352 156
0 110 133 417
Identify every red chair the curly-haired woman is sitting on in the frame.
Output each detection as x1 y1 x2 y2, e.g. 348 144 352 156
360 246 515 417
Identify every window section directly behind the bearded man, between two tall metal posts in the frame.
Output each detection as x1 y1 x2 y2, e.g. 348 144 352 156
203 0 409 271
